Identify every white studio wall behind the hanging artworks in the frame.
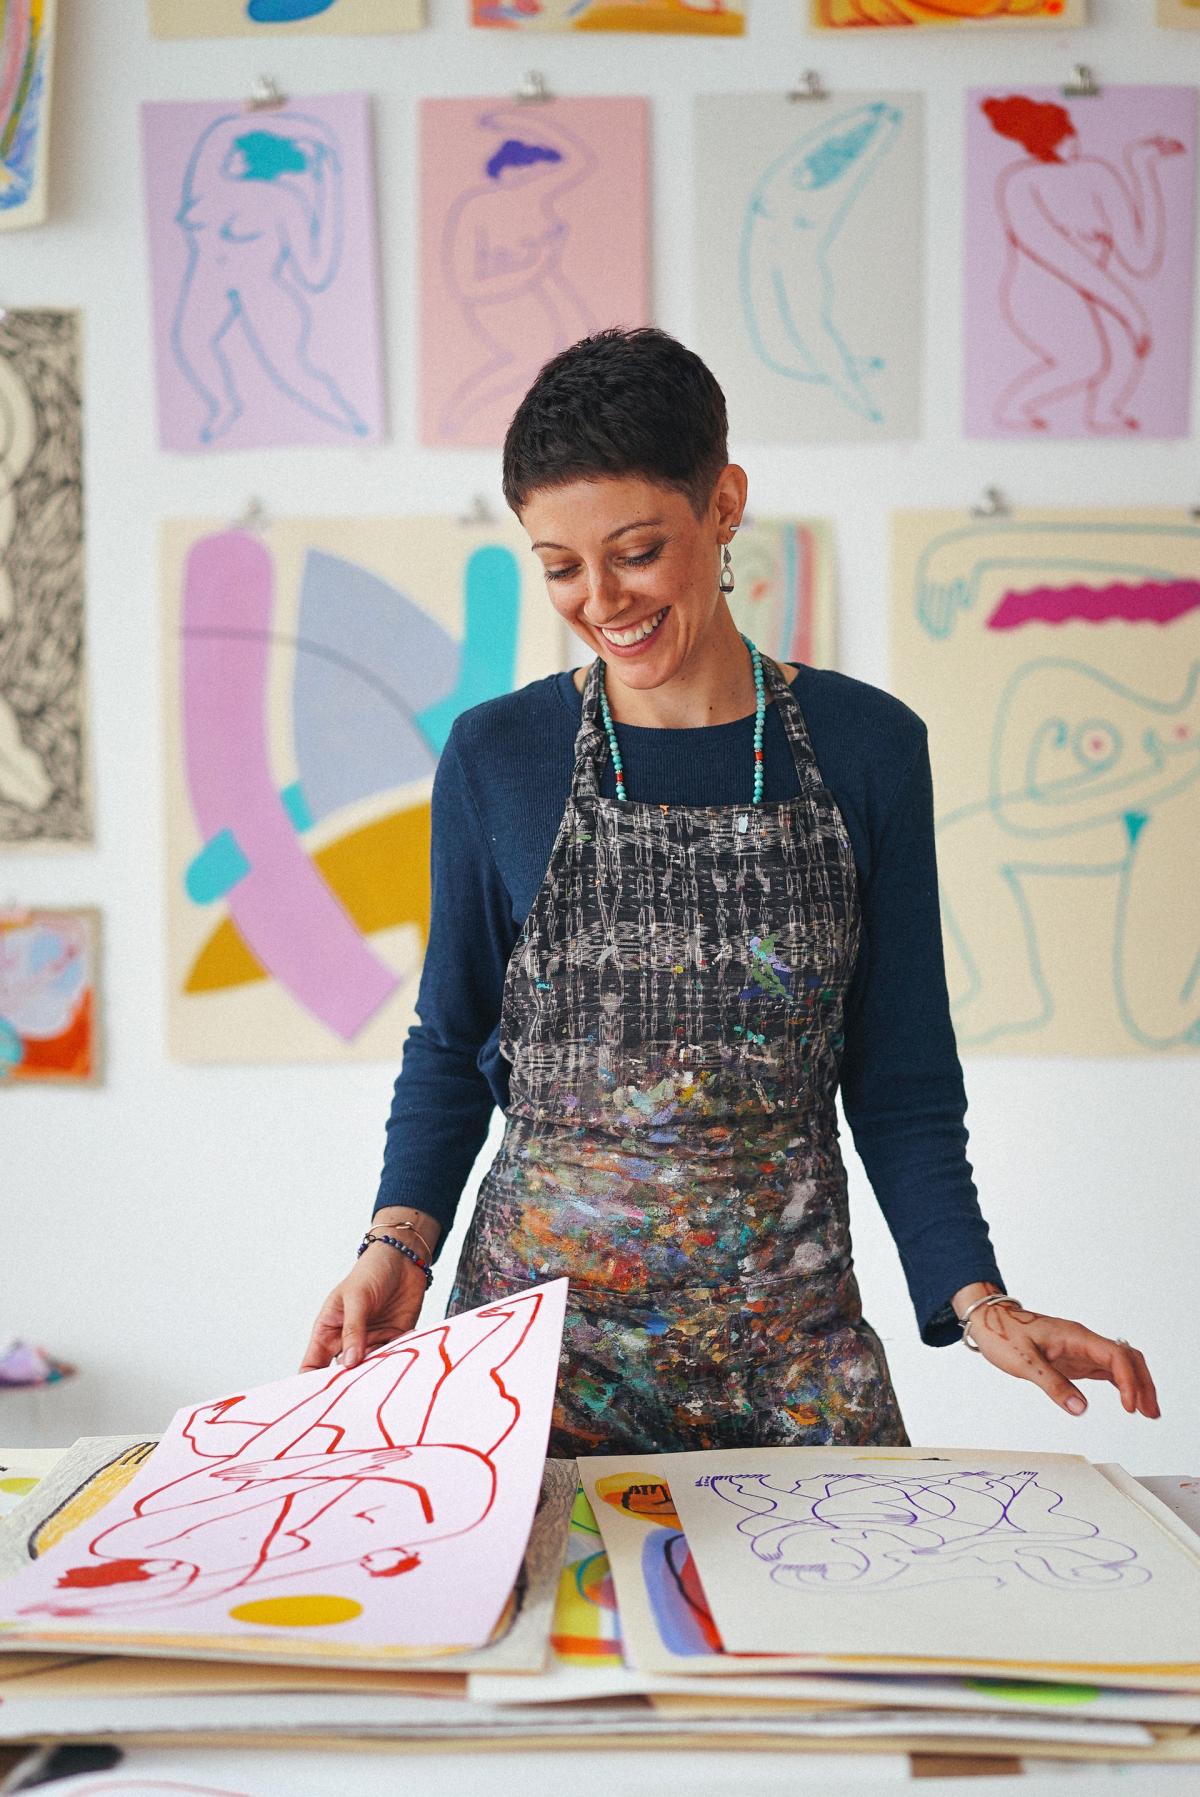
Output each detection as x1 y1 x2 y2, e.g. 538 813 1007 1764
0 0 1200 1472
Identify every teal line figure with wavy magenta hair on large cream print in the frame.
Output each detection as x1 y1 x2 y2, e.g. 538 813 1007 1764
916 521 1200 1048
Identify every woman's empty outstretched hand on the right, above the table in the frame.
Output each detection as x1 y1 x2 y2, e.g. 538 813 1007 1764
954 1294 1160 1416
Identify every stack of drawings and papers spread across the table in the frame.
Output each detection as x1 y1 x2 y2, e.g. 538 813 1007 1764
0 1281 1200 1761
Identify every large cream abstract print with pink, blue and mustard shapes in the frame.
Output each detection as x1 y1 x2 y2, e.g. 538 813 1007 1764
165 518 562 1062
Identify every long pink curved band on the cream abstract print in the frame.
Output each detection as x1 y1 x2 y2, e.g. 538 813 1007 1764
181 530 399 1042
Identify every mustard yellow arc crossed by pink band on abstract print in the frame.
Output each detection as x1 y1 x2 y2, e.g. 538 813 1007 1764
183 801 429 992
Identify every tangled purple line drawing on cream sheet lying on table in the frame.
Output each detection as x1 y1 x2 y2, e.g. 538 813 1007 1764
697 1466 1150 1601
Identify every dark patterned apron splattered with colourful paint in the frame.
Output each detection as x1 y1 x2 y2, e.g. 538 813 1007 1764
447 659 907 1454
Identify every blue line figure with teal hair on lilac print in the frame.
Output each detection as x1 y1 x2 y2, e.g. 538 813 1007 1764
171 111 366 444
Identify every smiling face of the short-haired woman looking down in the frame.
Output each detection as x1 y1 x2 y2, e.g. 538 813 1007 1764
521 465 746 690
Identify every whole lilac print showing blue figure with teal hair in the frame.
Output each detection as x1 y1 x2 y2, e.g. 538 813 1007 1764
142 95 383 451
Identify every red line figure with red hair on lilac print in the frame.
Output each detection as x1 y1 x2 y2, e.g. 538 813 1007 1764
981 93 1184 435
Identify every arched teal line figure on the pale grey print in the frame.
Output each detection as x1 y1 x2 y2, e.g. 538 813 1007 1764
740 101 904 424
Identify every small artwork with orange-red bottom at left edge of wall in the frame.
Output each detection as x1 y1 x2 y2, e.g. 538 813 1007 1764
0 911 101 1087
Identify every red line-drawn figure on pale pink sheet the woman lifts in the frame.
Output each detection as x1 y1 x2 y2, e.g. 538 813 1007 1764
18 1281 566 1641
